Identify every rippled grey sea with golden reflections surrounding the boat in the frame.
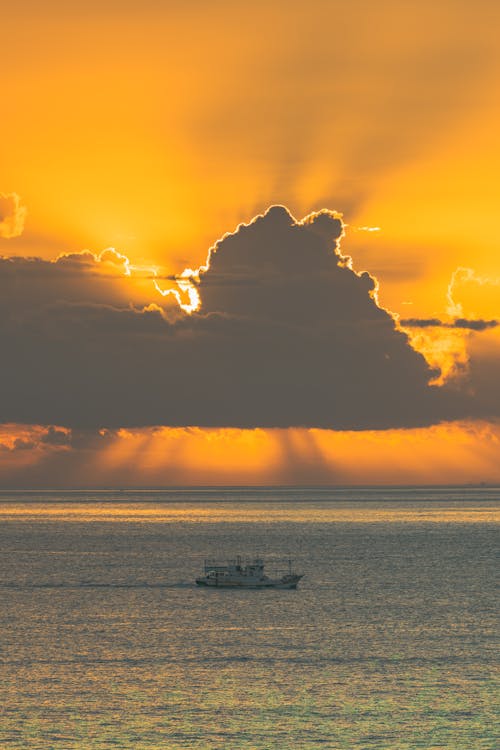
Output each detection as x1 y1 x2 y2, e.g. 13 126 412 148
0 487 500 750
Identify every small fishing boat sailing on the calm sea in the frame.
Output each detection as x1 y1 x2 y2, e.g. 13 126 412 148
196 556 303 589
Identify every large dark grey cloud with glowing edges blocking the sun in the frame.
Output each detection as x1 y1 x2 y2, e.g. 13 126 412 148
0 206 492 432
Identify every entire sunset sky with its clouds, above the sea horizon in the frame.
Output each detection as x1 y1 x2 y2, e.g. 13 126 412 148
0 0 500 488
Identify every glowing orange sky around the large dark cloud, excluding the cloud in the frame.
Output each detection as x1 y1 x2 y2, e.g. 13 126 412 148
0 0 500 486
